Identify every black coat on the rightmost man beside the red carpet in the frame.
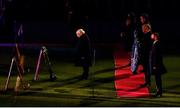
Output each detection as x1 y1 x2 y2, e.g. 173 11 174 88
150 41 167 74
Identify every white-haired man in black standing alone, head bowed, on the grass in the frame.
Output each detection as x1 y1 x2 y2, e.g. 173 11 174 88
76 29 92 79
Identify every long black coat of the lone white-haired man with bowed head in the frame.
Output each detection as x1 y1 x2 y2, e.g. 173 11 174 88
76 34 92 66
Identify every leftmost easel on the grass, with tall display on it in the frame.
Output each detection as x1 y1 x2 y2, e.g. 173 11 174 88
4 22 30 92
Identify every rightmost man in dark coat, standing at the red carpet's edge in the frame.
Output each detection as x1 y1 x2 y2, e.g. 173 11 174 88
149 33 167 97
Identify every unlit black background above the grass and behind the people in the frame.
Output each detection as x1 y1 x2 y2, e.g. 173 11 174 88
1 0 180 50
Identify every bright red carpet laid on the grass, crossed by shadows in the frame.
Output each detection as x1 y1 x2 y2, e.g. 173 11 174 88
114 48 149 97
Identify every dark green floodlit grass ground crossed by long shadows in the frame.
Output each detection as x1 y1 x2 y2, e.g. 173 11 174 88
0 45 180 106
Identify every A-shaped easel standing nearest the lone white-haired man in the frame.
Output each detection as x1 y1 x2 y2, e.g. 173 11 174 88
33 46 57 81
